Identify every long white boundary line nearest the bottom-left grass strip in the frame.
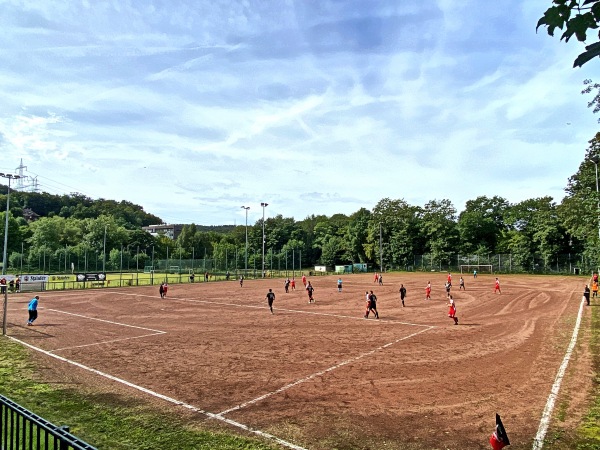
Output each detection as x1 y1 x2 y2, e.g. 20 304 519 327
7 336 306 450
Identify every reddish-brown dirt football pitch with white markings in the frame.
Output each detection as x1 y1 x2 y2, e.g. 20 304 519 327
8 273 596 449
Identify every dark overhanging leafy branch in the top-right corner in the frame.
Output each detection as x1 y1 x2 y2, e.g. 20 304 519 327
536 0 600 67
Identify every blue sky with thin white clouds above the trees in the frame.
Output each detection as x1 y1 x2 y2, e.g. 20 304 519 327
0 0 600 225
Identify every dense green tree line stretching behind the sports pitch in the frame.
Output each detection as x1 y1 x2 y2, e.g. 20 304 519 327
0 133 600 271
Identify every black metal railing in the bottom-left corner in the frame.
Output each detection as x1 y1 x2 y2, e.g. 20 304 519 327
0 395 96 450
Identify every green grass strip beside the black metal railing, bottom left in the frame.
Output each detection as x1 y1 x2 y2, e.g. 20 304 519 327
0 336 277 450
